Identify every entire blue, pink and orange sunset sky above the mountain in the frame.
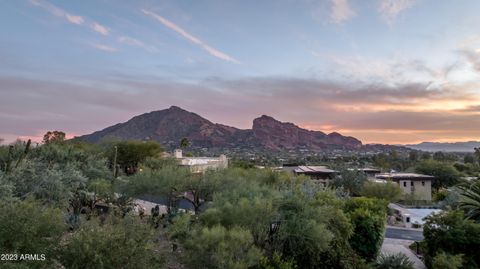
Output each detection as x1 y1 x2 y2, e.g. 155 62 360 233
0 0 480 144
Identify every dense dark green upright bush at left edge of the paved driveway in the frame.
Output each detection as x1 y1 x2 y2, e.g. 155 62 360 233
345 197 387 261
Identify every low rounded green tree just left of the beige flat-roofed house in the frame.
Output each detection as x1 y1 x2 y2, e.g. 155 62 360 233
360 181 403 202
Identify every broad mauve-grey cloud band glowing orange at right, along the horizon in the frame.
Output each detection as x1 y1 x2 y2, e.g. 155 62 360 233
0 74 480 143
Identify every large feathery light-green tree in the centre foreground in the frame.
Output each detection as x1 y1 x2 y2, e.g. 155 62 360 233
190 173 361 268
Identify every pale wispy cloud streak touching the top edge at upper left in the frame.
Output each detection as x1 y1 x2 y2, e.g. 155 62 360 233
30 0 109 35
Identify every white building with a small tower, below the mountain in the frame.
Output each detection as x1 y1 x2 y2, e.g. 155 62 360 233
174 149 228 173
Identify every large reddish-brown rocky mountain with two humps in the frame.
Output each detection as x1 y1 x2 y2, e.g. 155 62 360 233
78 106 362 151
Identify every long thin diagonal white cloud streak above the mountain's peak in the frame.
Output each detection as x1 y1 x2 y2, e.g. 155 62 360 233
141 9 240 64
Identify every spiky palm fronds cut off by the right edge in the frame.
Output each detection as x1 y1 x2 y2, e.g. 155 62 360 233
459 181 480 221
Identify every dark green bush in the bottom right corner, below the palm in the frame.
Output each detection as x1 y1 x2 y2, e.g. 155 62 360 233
422 210 480 269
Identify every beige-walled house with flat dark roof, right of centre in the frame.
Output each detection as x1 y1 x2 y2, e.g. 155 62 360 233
376 173 435 201
